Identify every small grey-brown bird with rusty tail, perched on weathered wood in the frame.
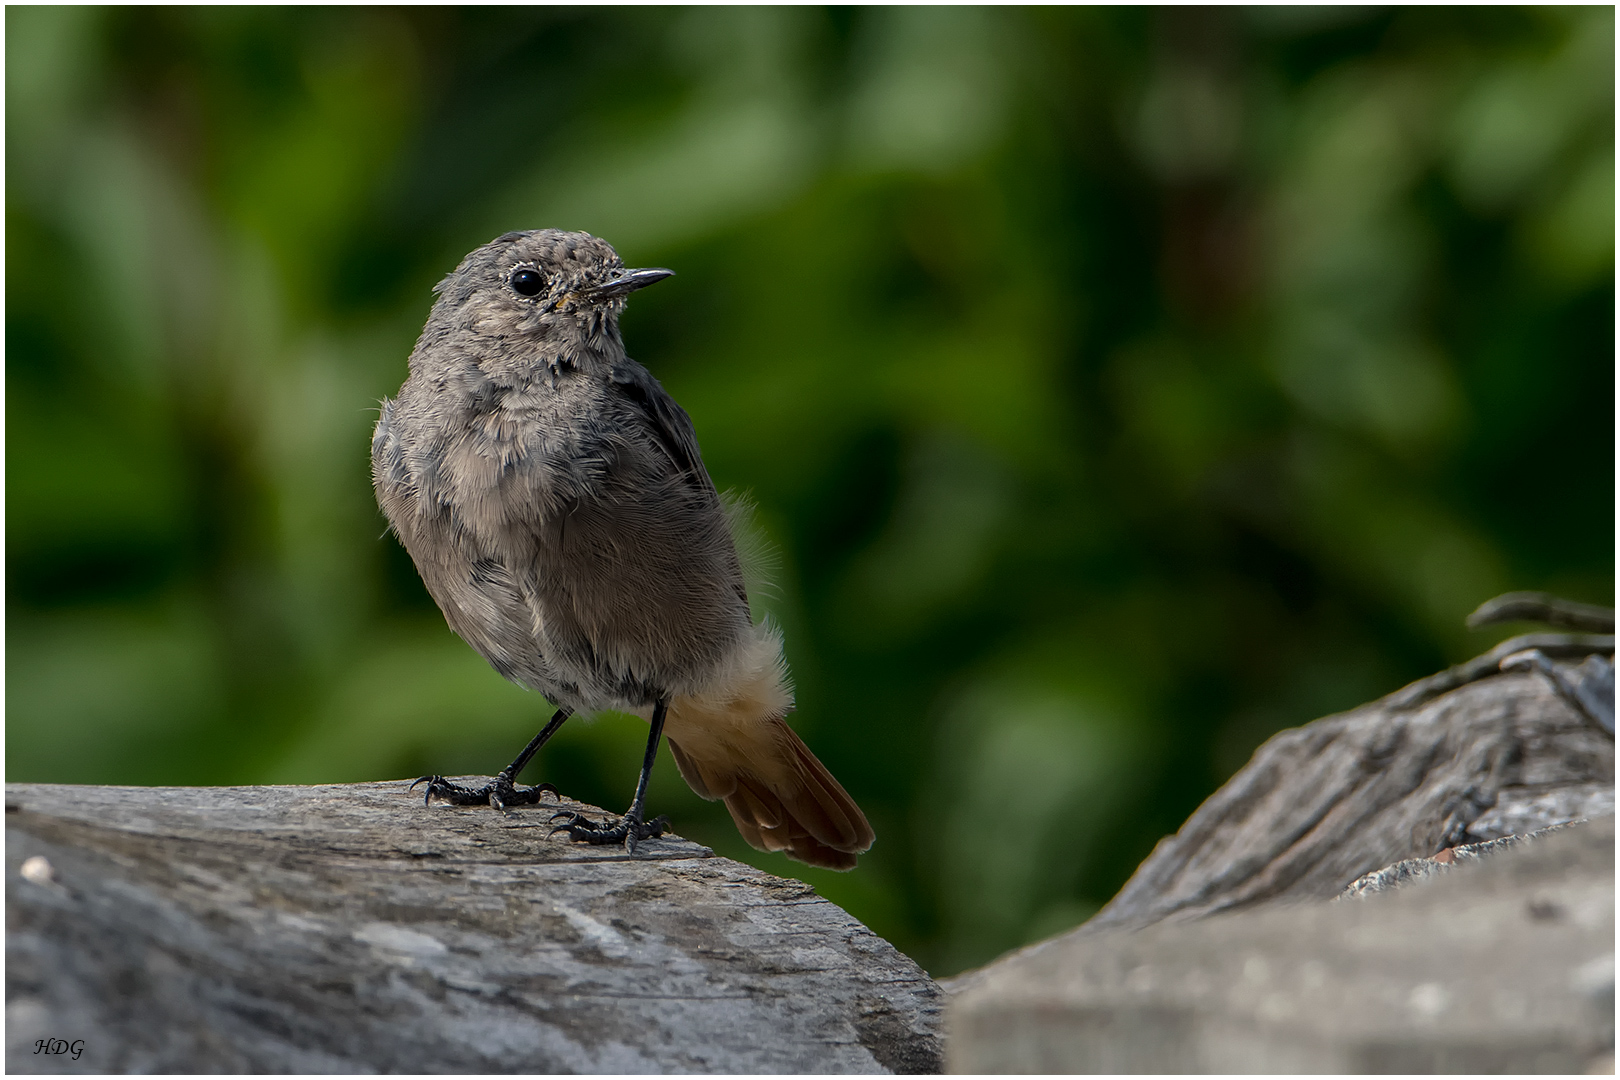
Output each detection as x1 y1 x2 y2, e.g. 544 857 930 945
371 228 873 870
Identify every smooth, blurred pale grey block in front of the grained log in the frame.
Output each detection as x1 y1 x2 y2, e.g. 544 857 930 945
948 816 1615 1074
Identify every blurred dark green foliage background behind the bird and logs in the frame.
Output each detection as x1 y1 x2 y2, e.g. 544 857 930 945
5 6 1615 975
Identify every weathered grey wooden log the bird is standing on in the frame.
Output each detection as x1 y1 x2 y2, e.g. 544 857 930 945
6 782 941 1072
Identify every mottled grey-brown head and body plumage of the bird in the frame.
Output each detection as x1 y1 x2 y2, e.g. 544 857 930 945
373 232 748 711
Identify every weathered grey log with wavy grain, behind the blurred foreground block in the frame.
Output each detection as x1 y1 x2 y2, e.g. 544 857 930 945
1085 635 1615 931
